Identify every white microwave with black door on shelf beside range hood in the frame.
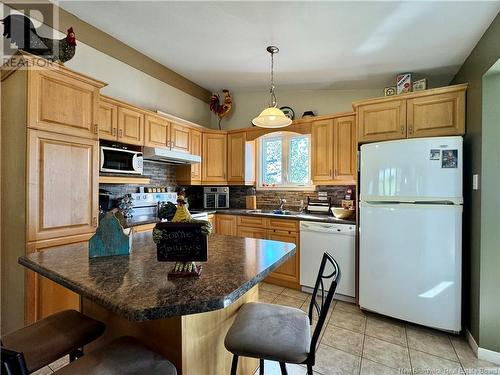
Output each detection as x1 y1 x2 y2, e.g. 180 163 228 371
99 146 143 174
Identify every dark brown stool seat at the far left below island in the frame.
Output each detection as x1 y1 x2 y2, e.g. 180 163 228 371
2 310 106 372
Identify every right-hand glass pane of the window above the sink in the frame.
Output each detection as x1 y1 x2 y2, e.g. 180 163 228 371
288 136 309 185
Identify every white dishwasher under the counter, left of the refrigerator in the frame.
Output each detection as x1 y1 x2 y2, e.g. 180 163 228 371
300 221 356 298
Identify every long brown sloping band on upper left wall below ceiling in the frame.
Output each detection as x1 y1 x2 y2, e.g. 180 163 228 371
3 2 211 103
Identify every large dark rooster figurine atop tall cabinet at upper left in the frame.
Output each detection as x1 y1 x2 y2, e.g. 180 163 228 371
2 14 76 63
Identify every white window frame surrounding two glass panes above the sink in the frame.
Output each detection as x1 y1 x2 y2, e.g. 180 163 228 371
256 131 315 191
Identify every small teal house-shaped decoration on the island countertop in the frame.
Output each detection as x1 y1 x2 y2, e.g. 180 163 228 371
89 211 132 258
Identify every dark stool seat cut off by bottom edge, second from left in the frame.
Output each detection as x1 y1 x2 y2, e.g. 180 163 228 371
54 337 177 375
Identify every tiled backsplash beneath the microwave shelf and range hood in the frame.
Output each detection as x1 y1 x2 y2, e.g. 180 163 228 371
99 160 177 197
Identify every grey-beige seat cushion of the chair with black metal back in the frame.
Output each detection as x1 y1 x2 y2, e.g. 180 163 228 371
224 302 311 363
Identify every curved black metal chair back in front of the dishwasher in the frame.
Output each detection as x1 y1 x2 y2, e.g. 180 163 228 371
307 253 340 365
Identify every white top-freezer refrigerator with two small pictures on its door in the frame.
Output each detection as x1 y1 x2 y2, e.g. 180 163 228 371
359 137 463 332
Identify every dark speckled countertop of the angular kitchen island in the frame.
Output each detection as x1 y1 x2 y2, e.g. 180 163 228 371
19 232 295 321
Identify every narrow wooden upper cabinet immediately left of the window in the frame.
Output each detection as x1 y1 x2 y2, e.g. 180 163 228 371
227 132 255 185
